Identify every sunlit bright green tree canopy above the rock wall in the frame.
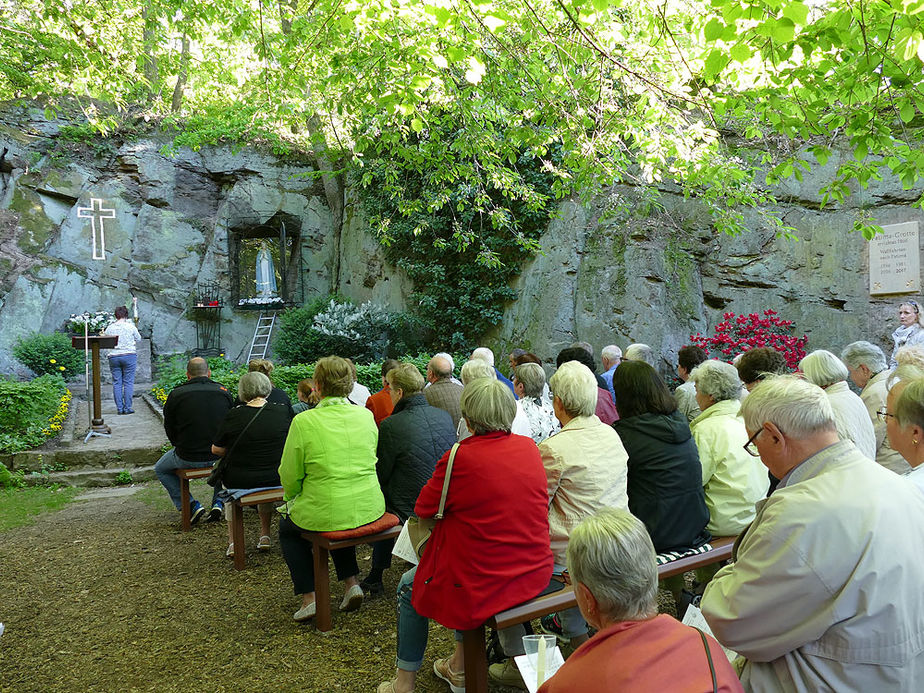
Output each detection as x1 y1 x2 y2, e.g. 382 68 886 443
0 0 924 238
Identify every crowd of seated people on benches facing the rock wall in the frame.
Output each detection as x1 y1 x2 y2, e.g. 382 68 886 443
155 332 924 693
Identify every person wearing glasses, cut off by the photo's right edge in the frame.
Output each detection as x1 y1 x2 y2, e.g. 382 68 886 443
879 366 924 491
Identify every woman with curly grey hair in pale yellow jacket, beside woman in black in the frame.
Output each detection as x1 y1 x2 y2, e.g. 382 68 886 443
690 360 770 536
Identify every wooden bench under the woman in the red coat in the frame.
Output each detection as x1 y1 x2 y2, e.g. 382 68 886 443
462 537 737 693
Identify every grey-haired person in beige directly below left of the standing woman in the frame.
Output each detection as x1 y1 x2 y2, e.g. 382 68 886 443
841 341 911 474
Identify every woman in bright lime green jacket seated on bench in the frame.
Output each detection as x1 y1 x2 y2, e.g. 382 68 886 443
279 356 385 621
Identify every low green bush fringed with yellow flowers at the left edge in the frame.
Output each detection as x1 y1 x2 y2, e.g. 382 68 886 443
0 375 71 454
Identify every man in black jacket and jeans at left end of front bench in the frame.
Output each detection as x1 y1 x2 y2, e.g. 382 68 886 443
154 357 234 523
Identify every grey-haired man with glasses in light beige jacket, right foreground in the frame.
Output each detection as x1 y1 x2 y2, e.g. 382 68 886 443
702 376 924 691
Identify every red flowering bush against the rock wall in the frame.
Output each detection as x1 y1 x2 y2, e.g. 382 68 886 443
690 309 808 370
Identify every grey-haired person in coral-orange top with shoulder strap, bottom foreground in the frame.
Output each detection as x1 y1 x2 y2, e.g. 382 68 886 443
539 510 742 693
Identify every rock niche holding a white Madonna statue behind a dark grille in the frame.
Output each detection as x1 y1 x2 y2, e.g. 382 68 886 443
228 212 302 309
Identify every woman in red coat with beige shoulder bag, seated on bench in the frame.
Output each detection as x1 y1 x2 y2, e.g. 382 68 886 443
378 378 552 693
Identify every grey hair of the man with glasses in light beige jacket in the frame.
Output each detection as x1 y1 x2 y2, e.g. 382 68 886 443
741 375 836 438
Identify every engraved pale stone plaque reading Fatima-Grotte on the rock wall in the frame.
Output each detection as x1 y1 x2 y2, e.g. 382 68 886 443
869 221 921 296
